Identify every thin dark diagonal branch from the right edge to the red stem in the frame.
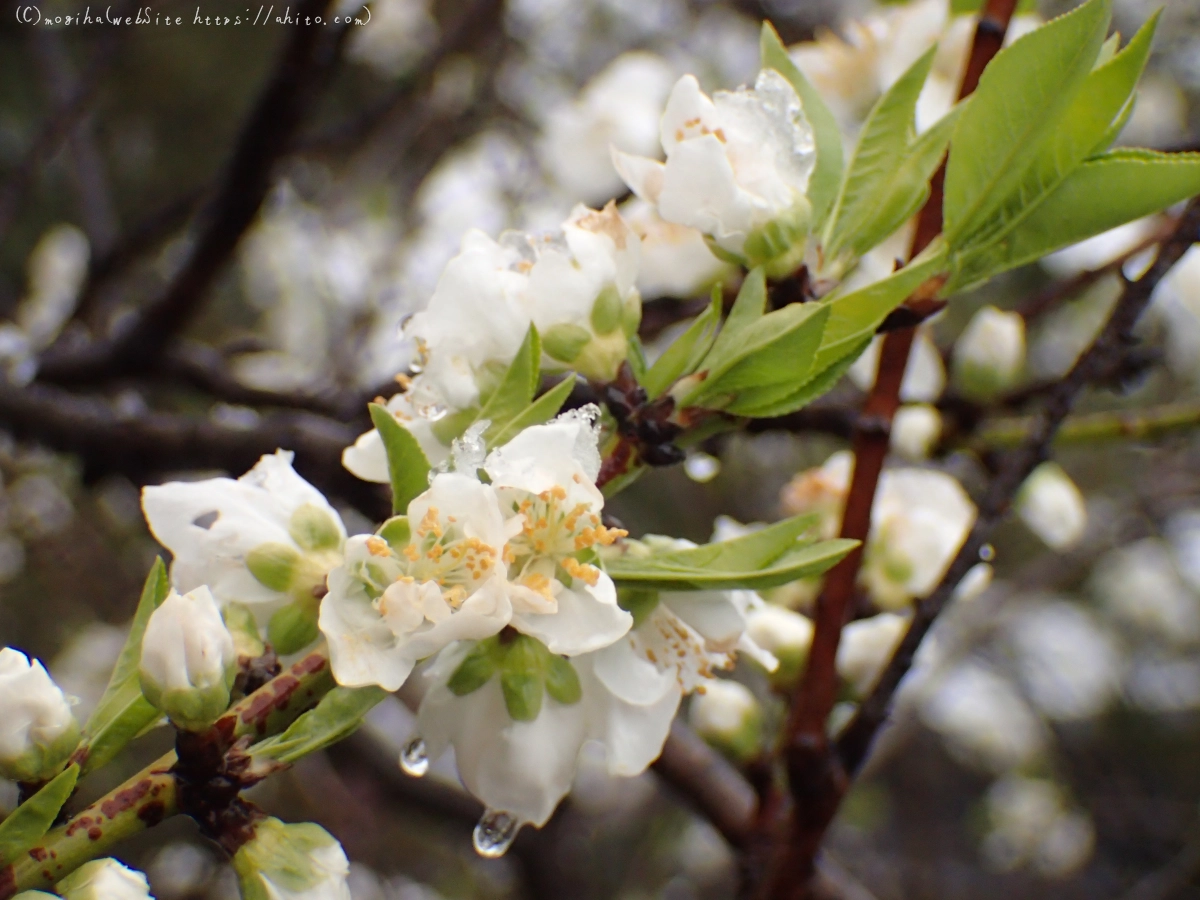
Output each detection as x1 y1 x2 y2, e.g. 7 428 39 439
838 199 1200 773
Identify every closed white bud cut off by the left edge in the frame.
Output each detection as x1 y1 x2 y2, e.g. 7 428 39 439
0 647 79 781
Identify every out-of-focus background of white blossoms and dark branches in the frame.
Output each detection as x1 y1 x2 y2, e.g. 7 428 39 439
0 0 1200 900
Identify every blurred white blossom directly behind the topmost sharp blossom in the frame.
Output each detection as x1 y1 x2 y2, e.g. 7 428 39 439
539 50 674 203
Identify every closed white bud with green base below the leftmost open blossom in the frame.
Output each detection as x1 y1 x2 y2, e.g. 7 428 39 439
138 587 238 730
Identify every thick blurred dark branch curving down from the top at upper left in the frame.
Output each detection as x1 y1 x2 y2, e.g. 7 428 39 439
40 0 347 384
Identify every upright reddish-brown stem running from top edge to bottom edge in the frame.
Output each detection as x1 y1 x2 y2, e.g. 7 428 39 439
760 0 1016 900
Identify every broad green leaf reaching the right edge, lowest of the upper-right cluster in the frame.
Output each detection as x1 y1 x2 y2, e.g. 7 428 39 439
948 150 1200 288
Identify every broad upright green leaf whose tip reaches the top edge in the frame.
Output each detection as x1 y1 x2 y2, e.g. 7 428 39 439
943 0 1111 250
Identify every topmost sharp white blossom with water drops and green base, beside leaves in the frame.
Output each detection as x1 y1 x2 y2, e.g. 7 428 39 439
613 68 816 269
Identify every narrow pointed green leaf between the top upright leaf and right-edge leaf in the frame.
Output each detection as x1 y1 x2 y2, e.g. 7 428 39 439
950 8 1158 259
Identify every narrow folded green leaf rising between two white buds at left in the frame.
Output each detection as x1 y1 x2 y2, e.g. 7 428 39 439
80 558 170 773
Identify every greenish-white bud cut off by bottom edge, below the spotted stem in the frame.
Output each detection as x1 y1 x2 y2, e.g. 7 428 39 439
233 818 350 900
